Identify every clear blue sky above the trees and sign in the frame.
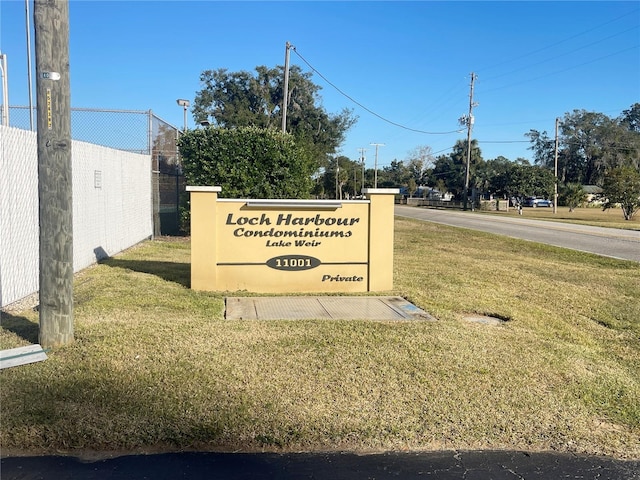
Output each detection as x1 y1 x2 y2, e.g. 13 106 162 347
0 0 640 171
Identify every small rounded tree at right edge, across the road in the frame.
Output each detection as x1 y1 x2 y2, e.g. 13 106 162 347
602 166 640 220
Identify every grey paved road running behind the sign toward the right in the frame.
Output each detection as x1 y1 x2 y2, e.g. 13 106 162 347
395 205 640 262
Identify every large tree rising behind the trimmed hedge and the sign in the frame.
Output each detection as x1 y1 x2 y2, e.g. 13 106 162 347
193 65 356 167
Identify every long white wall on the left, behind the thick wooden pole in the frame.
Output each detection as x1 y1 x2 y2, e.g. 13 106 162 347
0 126 153 306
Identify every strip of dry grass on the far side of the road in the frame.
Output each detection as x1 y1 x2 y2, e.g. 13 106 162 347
482 207 640 230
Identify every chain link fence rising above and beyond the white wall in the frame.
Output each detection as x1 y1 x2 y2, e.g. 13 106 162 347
9 106 186 236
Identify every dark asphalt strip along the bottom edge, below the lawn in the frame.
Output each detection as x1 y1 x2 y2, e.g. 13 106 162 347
1 451 640 480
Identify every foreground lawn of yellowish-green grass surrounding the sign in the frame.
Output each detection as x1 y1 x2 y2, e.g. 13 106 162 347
0 219 640 458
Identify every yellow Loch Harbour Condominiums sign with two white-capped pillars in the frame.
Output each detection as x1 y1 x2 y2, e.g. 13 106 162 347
187 187 398 293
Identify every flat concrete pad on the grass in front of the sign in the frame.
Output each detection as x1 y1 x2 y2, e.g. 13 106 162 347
225 296 435 320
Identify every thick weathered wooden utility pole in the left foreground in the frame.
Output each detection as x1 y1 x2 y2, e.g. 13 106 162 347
33 0 73 347
